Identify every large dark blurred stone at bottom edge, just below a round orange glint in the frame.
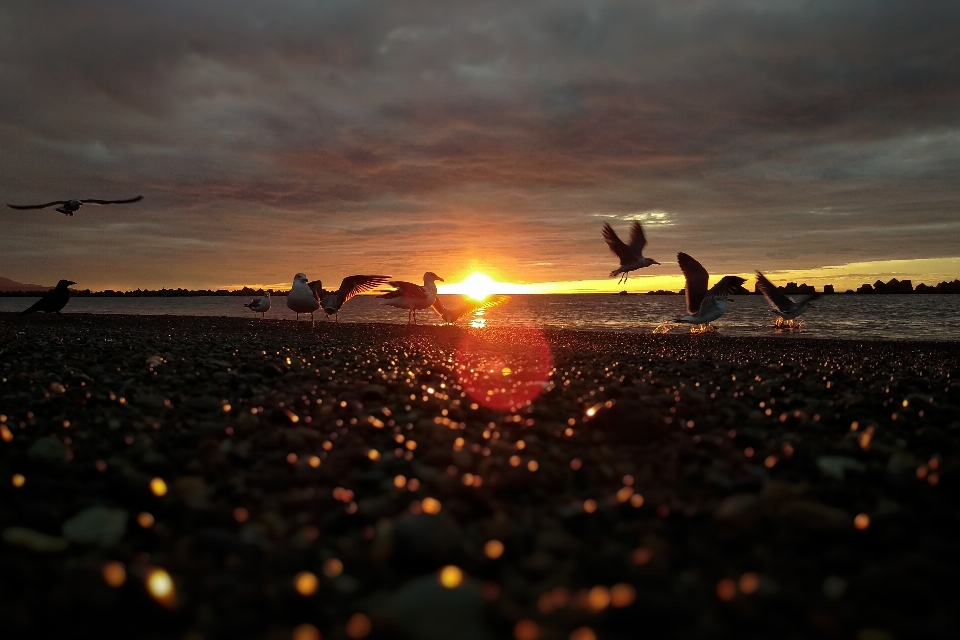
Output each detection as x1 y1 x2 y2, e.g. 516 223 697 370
389 575 487 640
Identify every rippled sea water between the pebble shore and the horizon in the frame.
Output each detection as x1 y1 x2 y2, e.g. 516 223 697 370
0 294 960 340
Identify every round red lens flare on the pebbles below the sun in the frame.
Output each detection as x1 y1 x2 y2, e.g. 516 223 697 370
455 329 553 411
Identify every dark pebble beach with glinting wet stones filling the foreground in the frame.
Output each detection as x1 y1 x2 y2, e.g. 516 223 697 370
0 314 960 640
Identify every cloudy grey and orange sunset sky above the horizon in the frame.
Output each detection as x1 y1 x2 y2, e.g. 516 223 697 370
0 0 960 291
